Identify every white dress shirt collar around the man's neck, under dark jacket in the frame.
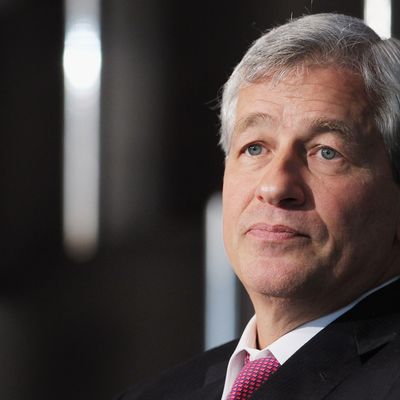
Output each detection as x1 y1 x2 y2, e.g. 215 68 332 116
222 277 399 400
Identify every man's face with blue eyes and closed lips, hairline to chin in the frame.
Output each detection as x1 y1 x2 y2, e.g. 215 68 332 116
223 67 400 311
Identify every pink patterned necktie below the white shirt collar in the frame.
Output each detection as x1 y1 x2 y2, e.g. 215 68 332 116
228 353 280 400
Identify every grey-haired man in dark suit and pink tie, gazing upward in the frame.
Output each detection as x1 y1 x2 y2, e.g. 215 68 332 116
121 14 400 400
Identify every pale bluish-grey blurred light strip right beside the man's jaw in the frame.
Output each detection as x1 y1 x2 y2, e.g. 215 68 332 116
204 193 238 350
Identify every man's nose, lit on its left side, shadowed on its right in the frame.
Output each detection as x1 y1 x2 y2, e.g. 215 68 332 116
255 150 306 208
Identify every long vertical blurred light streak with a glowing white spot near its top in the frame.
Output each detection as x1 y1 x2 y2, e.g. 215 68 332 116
63 0 101 261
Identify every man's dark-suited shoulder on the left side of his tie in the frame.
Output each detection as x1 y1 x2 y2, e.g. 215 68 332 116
115 341 237 400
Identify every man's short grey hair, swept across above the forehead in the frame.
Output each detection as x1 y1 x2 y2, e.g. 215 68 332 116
220 14 400 183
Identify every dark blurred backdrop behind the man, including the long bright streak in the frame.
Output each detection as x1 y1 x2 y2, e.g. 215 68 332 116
0 0 400 400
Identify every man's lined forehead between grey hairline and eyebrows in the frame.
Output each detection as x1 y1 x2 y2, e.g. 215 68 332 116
235 66 370 131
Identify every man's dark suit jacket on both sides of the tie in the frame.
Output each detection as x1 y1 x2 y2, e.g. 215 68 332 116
118 281 400 400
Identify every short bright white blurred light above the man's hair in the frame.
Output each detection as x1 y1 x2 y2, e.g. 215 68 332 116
364 0 392 39
